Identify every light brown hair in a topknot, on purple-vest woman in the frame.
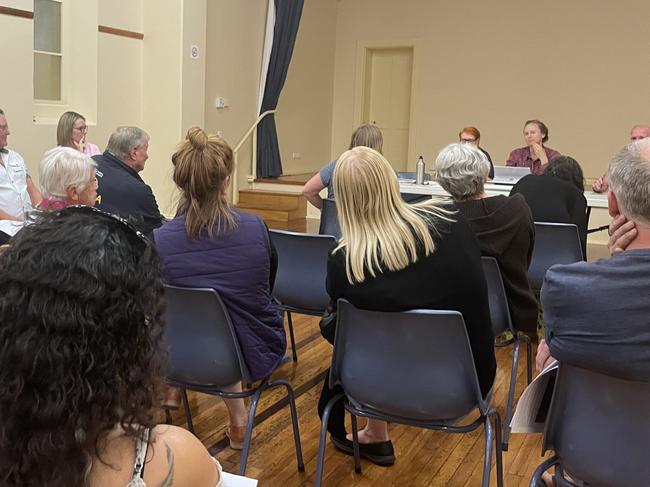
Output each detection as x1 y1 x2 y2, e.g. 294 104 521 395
172 127 237 239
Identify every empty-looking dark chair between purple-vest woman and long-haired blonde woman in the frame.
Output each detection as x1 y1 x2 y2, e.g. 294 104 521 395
269 230 336 362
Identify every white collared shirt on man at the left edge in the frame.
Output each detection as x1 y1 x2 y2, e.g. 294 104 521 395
0 149 33 235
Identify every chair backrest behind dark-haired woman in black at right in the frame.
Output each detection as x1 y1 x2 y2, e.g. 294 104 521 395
528 222 584 292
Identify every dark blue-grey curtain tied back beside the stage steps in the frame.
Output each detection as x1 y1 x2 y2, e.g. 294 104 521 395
257 0 304 178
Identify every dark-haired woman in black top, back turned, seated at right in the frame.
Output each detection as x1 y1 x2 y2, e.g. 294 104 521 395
510 156 587 256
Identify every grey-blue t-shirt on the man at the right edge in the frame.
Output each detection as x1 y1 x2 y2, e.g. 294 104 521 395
541 249 650 382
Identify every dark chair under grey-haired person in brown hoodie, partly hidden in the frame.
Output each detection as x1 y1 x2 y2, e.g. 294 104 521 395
481 256 532 451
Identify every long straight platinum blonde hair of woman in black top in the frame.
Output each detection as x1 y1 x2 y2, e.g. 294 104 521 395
334 147 451 284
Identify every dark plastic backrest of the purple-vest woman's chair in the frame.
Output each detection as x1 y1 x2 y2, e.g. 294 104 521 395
165 285 250 387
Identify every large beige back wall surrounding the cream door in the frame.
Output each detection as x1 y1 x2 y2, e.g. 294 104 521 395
331 0 650 177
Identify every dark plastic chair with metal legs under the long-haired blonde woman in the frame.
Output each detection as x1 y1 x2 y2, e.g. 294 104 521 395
316 299 503 487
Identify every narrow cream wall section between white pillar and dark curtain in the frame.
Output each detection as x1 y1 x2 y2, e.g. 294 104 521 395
205 0 267 196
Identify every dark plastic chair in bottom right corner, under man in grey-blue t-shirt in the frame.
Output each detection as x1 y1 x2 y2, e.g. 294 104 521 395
530 363 650 487
